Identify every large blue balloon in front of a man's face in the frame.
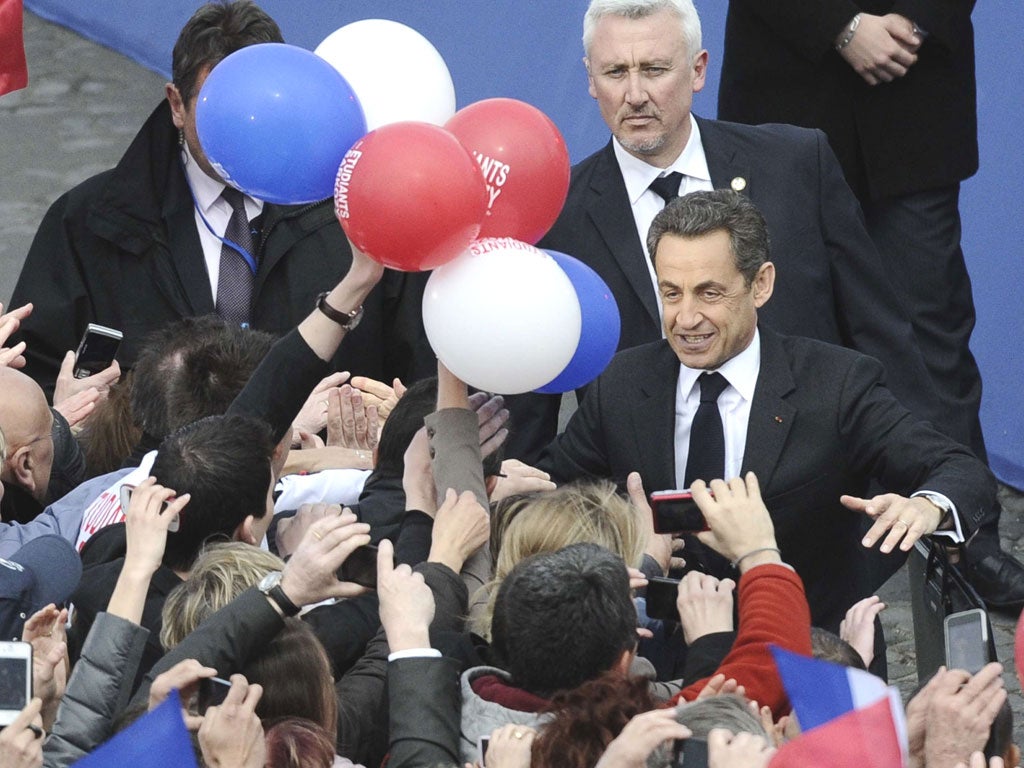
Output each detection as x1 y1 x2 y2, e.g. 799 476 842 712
196 43 367 205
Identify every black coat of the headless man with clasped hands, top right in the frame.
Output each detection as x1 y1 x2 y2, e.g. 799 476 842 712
718 0 978 200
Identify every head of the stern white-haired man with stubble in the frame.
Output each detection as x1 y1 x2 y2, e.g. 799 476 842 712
584 9 708 168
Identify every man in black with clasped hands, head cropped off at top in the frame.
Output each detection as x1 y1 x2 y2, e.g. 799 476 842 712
718 0 1024 610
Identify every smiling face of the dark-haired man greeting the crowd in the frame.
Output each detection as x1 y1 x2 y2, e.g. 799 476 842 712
654 229 775 371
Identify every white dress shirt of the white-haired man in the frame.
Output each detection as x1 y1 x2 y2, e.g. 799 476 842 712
611 115 715 336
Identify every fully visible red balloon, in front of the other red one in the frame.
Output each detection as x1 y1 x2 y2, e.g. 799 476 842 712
334 122 487 272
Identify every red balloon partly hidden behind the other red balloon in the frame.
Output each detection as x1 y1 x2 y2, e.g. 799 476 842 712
444 98 569 245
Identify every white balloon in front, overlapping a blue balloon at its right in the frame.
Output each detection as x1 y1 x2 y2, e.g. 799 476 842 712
423 238 581 394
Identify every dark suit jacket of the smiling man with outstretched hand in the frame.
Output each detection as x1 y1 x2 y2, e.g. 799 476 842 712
541 326 995 628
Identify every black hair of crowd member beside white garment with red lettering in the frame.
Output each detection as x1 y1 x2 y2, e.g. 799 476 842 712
152 416 274 570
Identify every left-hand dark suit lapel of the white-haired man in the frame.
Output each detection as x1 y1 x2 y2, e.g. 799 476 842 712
587 141 662 328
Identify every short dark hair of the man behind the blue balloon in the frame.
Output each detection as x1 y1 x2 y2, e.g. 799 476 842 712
171 0 285 108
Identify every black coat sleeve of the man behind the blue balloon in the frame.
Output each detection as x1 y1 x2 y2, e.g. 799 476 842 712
10 195 94 398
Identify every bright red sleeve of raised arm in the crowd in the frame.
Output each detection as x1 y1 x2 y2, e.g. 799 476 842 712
675 565 811 718
